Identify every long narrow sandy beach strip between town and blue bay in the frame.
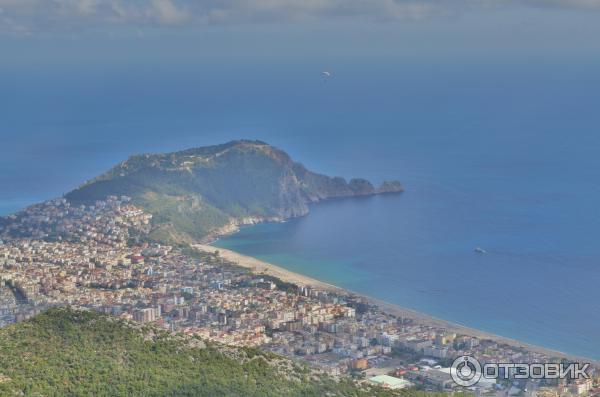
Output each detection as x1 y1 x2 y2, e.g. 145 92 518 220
193 244 600 365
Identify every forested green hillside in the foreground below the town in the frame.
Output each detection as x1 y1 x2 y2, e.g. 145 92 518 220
0 309 424 397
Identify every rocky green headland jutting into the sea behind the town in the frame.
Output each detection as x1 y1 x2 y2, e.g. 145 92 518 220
66 140 402 243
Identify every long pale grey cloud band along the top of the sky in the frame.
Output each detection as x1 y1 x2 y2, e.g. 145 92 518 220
0 0 600 33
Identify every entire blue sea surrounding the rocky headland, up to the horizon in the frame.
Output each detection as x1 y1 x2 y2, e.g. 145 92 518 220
0 55 600 359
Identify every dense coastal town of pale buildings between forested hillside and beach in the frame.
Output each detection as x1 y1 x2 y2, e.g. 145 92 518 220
0 197 597 397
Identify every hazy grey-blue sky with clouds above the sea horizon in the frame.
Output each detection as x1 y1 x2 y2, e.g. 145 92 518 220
0 0 600 68
